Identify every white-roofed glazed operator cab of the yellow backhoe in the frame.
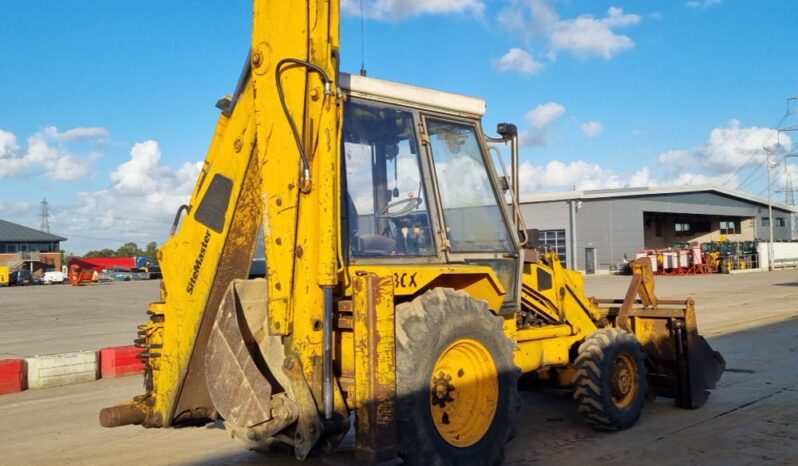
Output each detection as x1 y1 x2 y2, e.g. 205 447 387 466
341 75 520 301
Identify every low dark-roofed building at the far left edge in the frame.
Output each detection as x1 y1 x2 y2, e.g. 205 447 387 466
0 220 66 274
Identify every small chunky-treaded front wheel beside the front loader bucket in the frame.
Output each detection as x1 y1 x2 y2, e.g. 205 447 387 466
574 328 646 430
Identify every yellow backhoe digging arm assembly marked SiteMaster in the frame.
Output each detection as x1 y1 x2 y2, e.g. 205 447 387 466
101 0 346 456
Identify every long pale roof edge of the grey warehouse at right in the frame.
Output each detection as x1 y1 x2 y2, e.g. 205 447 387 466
521 185 798 212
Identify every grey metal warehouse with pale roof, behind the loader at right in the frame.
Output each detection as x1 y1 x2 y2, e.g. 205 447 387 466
520 186 796 273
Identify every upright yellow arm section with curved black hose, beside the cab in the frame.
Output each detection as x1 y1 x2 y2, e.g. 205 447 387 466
251 0 343 394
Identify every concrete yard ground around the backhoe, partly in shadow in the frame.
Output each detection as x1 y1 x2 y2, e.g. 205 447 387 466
0 270 798 465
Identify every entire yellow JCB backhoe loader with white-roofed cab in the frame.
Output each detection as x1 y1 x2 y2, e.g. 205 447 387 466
100 0 724 465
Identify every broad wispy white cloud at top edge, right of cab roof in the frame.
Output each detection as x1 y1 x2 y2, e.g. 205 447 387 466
498 0 642 60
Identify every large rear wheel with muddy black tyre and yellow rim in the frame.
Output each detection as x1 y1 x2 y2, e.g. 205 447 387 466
396 288 520 466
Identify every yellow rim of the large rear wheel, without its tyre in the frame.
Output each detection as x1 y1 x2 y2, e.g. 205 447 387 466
430 339 499 448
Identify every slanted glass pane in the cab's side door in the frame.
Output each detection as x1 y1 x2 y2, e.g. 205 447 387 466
426 118 513 252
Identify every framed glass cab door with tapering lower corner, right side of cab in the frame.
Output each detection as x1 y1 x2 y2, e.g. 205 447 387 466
423 115 521 312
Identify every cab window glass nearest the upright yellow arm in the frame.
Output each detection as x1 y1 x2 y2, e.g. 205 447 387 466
343 99 435 257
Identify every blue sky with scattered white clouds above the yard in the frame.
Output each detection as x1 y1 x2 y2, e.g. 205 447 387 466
0 0 798 254
